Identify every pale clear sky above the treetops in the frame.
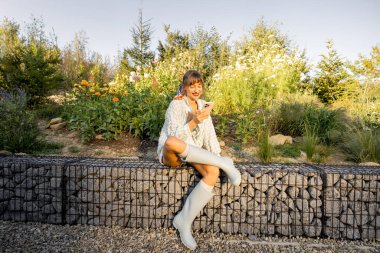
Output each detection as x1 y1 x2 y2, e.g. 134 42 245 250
0 0 380 63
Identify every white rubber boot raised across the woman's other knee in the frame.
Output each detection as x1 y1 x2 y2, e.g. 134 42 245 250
185 144 241 186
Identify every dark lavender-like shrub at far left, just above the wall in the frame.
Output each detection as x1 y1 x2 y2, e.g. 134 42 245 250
0 89 61 153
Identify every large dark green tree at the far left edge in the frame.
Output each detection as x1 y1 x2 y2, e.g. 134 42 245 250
0 18 62 103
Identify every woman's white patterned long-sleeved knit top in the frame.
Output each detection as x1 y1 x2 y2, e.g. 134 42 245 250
157 97 220 159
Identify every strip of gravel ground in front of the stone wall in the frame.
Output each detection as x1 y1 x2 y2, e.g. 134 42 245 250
0 221 380 253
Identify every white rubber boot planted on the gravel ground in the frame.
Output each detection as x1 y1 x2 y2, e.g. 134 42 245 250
173 180 214 250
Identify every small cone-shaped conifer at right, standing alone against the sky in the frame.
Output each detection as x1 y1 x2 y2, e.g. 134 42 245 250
312 41 357 104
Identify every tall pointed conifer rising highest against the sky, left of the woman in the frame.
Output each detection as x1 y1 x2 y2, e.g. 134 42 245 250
126 10 154 71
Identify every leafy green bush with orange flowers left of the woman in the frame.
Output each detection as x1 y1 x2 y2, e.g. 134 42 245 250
64 80 169 142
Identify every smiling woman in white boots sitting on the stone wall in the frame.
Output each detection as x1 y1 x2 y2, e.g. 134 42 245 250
157 70 241 250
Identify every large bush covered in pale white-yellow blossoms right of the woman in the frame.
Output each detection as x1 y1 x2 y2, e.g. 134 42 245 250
209 22 308 114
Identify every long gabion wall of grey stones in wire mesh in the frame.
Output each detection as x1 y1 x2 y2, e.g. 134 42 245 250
0 157 380 239
